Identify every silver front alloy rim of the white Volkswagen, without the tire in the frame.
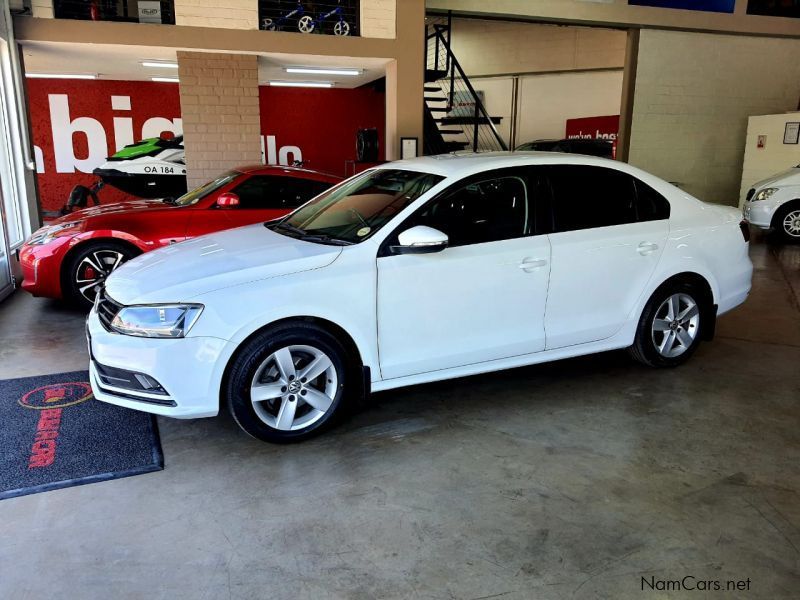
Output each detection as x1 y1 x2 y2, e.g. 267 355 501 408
250 345 338 431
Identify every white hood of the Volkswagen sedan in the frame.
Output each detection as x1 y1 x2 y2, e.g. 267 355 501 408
106 223 342 304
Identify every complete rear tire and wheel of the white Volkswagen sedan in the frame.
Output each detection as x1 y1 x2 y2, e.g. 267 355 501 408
628 282 708 368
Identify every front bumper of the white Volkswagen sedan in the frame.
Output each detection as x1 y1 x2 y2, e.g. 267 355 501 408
86 309 234 419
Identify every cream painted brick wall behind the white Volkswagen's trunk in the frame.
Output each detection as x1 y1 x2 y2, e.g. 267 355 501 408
629 30 800 206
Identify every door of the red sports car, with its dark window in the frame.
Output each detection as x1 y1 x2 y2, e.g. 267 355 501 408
185 175 330 235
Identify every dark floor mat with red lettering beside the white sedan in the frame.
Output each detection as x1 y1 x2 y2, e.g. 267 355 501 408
0 371 164 500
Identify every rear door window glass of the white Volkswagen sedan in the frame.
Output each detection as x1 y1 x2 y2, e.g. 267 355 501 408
548 165 637 232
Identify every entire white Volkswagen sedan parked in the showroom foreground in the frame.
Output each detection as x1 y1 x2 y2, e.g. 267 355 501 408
87 153 752 441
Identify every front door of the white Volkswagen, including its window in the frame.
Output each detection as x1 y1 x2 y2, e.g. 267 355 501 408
377 169 550 379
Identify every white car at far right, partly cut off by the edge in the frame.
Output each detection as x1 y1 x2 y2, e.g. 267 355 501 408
742 165 800 242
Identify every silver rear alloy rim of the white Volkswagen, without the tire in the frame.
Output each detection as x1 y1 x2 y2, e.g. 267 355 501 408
652 294 700 358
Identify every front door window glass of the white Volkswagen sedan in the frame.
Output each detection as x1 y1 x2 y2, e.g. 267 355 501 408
412 176 532 247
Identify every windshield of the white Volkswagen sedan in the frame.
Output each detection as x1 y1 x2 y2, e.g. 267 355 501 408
276 169 444 244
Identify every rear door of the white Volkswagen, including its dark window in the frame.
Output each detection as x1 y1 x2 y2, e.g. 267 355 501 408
545 165 669 350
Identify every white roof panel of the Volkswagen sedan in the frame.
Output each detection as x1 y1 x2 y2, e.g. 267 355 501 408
385 151 644 178
